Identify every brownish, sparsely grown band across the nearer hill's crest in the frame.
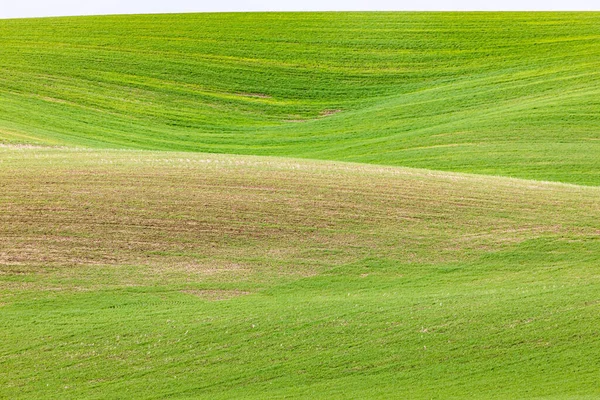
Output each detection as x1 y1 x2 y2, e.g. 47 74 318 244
0 149 600 290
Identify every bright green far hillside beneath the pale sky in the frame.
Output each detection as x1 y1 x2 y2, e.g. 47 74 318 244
0 13 600 185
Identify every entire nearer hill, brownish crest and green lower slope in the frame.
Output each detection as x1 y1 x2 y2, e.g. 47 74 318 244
0 146 600 399
